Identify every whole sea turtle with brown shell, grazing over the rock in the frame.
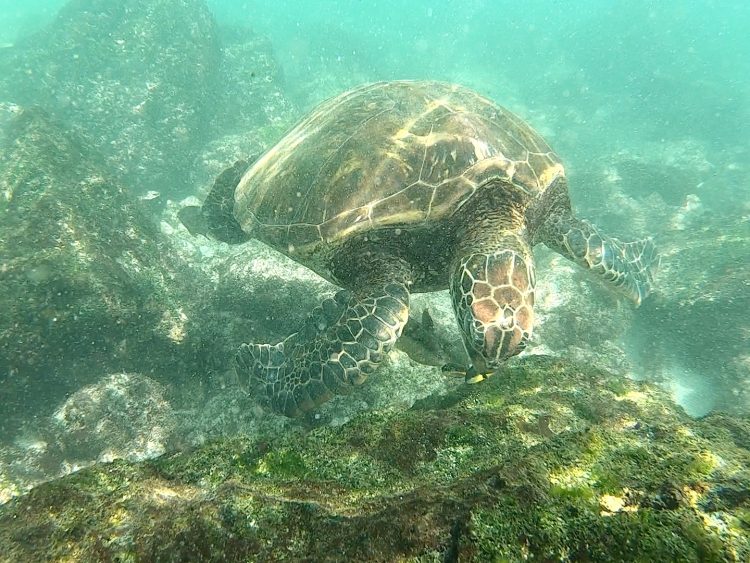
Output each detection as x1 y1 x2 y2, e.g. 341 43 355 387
181 81 658 416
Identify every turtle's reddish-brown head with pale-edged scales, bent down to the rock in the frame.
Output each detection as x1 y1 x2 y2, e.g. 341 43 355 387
450 243 534 381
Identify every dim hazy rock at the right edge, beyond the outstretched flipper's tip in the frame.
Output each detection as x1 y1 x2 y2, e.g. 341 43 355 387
633 216 750 415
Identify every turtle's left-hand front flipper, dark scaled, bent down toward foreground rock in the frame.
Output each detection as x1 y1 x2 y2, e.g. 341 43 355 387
236 283 409 416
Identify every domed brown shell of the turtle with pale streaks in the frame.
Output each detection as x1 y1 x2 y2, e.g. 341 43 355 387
234 81 564 271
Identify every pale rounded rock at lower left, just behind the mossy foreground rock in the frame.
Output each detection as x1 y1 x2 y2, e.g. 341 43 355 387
0 373 178 503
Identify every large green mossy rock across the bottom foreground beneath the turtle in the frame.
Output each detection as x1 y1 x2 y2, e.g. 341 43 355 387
0 356 750 561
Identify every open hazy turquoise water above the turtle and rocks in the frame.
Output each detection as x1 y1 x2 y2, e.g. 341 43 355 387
0 0 750 154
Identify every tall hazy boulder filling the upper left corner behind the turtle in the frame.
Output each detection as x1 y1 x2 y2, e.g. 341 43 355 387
0 0 220 198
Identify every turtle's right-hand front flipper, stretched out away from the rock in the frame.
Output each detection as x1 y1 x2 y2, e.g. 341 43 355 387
542 215 659 305
